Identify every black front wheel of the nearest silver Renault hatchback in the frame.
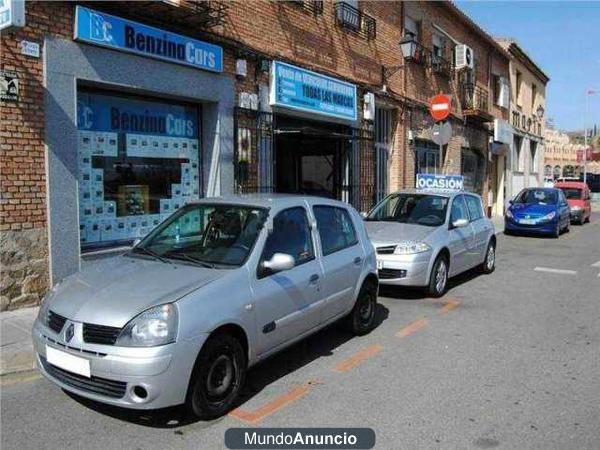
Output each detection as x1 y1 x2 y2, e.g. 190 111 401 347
185 334 246 419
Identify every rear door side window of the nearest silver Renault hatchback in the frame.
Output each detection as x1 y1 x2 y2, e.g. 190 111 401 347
313 206 358 256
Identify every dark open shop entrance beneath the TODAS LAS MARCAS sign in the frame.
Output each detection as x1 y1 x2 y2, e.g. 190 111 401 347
274 115 352 199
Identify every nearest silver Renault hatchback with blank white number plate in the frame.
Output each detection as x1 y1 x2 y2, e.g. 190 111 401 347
33 195 378 418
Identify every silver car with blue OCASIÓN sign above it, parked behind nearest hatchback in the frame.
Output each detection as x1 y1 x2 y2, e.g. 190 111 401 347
365 190 496 297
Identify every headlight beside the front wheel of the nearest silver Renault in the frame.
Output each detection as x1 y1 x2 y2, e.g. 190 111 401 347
115 303 179 347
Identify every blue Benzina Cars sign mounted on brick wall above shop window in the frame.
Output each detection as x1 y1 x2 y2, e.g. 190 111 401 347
75 5 223 72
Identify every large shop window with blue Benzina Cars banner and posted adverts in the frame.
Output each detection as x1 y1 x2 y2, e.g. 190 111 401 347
77 90 202 248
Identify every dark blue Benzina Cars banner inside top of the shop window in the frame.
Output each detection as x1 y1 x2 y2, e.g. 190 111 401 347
77 92 198 139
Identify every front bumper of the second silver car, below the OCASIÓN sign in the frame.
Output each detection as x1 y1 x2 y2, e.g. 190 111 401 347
377 250 433 286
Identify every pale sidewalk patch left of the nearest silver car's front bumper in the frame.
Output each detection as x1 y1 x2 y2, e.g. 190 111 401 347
0 307 39 375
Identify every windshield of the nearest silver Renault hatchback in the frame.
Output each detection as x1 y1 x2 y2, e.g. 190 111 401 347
132 204 268 267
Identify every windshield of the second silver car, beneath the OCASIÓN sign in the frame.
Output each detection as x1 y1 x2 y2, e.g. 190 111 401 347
365 194 448 227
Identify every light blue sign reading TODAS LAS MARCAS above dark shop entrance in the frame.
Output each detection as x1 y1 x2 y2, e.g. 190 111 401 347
271 61 357 120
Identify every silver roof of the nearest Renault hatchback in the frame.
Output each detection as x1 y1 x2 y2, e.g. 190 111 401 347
188 193 351 208
